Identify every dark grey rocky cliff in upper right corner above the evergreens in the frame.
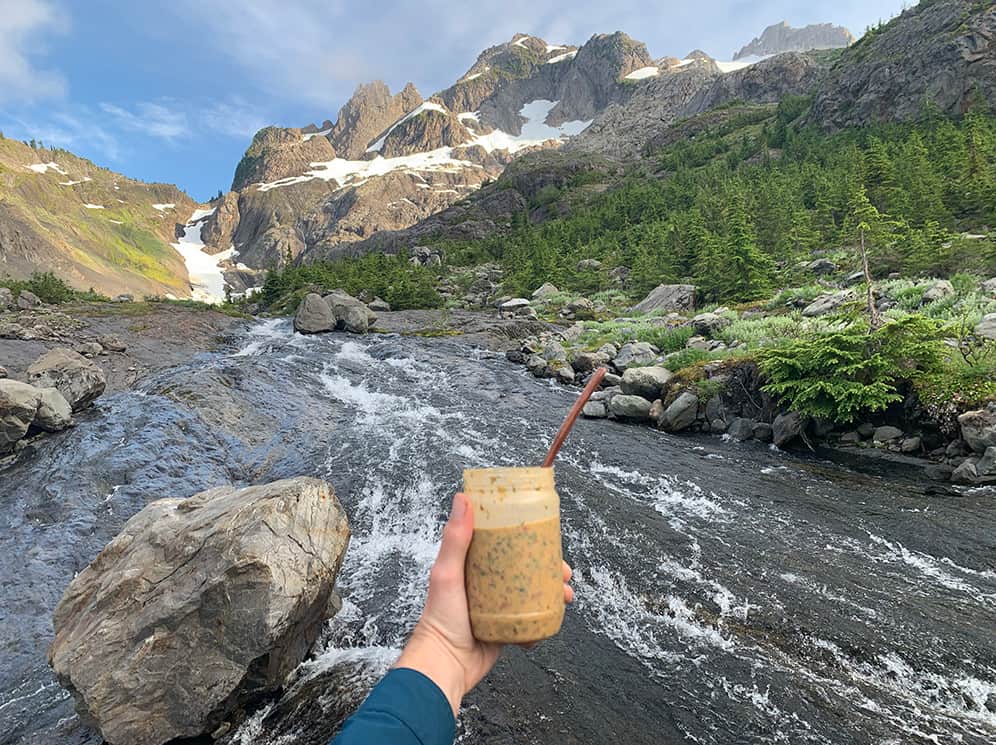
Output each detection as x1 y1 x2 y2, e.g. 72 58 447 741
809 0 996 128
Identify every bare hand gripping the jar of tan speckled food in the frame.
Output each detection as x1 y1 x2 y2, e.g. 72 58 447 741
394 494 574 716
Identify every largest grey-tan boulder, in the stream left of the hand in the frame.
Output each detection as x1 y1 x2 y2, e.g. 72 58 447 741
48 478 349 745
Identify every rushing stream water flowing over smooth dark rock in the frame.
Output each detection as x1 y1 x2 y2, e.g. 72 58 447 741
0 321 996 745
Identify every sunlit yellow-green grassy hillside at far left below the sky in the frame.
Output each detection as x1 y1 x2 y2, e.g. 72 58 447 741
0 139 195 297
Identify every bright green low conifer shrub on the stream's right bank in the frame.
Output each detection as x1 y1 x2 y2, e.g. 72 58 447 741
758 316 942 422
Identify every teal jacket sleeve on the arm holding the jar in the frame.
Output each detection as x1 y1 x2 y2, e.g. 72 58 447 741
331 668 456 745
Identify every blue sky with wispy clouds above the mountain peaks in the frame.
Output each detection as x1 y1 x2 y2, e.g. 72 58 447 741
0 0 911 199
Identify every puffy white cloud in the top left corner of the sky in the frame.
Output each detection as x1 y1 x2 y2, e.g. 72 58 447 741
0 0 68 101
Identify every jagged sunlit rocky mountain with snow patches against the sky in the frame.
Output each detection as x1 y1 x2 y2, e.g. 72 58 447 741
203 27 813 267
